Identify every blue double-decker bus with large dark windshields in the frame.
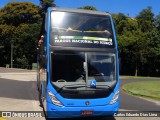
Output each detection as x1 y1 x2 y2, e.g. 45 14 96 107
37 7 120 118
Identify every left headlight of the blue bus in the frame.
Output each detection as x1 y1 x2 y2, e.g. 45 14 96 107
48 90 63 107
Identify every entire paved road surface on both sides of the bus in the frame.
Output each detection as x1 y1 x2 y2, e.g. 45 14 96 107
0 68 160 120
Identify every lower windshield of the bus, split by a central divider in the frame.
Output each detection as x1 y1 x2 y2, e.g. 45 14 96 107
51 52 116 87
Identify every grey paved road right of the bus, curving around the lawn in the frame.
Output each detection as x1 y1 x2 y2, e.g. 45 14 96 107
120 78 160 111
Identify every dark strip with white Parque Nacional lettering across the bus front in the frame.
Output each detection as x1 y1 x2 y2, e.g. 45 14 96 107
51 35 114 48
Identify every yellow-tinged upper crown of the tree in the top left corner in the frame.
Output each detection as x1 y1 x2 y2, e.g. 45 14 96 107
0 2 41 26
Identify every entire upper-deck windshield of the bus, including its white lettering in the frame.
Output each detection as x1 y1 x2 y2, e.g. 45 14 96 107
51 11 114 48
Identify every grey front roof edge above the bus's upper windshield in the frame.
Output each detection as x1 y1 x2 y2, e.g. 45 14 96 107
49 7 110 16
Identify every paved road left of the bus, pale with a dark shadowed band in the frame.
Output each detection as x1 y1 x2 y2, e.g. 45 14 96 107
0 68 45 120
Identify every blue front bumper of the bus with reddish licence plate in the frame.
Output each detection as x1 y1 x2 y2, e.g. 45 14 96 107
46 102 119 118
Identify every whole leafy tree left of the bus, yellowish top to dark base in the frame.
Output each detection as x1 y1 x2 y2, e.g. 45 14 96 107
0 2 42 66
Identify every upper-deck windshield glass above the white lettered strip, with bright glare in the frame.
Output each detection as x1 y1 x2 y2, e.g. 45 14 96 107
51 11 112 37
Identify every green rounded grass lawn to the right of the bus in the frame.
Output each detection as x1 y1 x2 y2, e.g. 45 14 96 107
122 81 160 100
